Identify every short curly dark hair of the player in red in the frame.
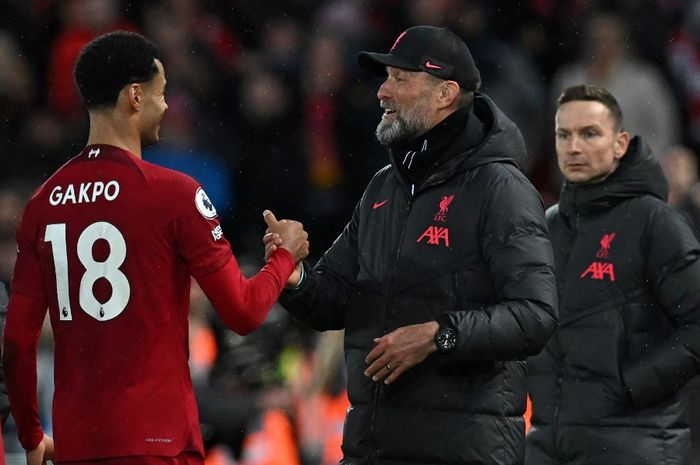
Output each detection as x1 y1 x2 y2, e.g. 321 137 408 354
73 31 158 109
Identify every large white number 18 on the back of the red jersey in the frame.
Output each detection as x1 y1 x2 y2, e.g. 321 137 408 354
44 221 131 321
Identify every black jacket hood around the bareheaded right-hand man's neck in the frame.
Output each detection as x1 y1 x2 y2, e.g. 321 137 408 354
559 136 668 216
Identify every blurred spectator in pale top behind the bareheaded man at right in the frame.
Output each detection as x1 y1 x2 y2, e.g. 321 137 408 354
552 14 679 156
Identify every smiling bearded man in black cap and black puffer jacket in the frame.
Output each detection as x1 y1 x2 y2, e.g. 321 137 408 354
264 26 557 465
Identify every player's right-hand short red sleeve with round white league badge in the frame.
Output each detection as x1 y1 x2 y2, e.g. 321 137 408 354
174 178 233 279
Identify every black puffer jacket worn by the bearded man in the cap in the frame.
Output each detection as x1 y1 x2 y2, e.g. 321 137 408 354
282 95 556 465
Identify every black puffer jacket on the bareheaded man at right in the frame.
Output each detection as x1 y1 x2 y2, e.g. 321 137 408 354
526 138 700 465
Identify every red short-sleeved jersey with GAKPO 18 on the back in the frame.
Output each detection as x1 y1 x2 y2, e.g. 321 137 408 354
12 145 249 460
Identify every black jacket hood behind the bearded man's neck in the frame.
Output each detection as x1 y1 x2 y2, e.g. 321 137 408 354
391 92 527 187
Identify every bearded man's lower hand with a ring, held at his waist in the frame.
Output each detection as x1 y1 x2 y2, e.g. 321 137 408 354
365 321 439 384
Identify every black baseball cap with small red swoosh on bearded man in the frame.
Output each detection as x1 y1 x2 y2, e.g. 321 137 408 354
357 26 481 90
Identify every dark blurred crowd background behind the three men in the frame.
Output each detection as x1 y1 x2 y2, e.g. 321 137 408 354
0 0 700 465
